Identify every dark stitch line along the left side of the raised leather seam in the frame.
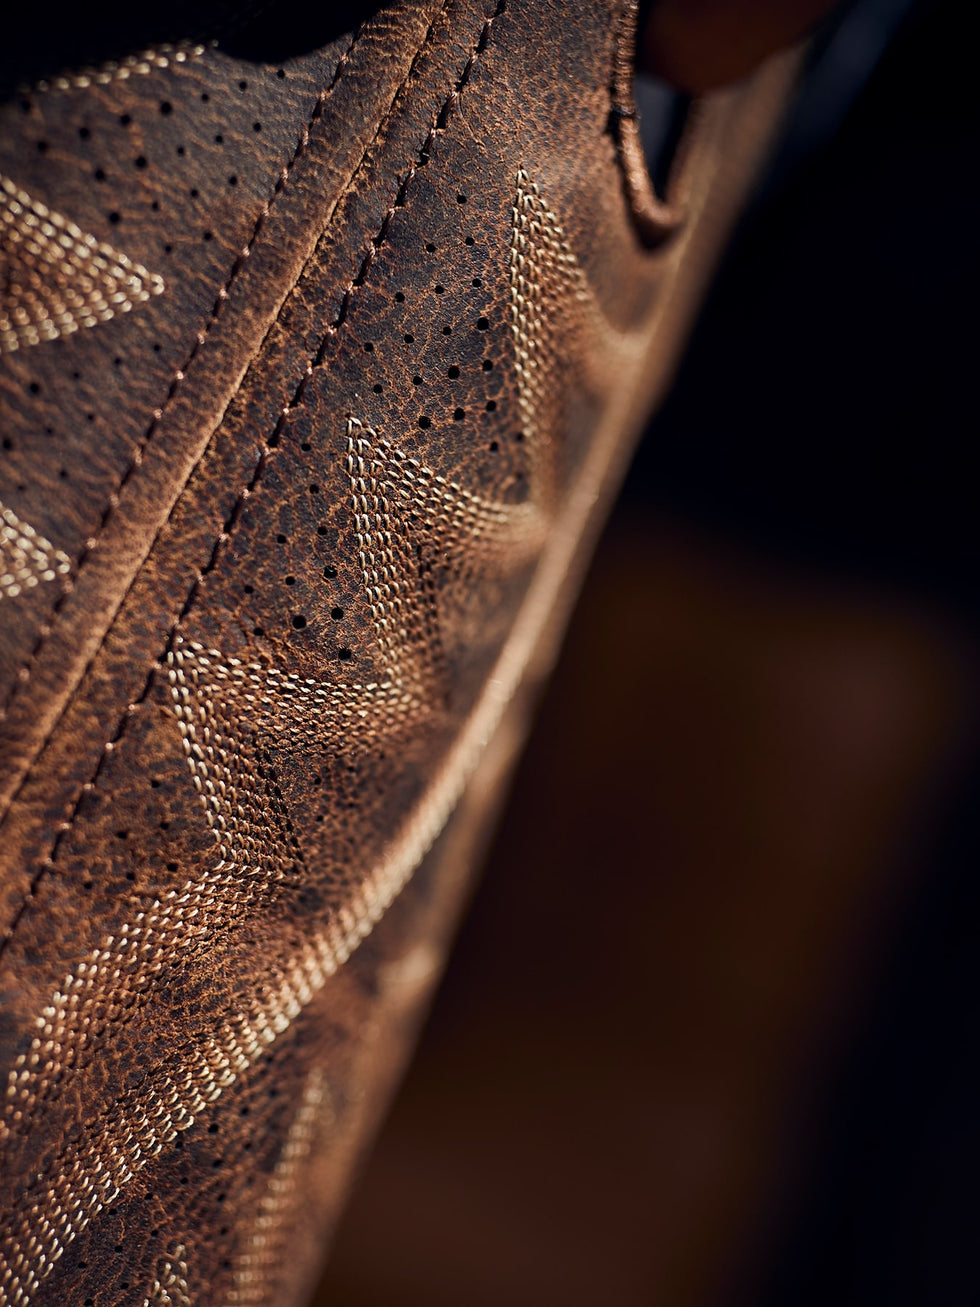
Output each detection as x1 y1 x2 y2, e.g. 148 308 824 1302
0 29 363 720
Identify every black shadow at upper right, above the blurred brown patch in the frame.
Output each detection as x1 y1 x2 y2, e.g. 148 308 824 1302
626 0 980 620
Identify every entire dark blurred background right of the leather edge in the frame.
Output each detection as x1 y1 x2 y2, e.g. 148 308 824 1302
318 0 980 1307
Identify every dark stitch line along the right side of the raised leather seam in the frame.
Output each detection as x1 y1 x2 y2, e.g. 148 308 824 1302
0 0 507 961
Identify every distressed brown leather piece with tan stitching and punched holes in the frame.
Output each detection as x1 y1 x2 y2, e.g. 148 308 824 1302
0 0 785 1307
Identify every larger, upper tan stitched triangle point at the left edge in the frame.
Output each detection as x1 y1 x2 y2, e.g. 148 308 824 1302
0 174 163 354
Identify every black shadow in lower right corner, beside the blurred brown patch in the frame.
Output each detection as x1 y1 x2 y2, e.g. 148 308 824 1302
745 762 980 1307
